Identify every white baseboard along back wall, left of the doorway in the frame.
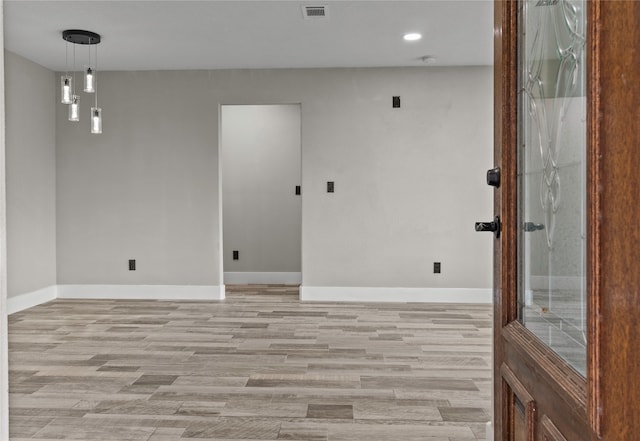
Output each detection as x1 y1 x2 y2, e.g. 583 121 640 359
58 285 225 300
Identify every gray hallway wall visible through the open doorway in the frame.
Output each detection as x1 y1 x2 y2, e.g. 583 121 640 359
221 104 302 272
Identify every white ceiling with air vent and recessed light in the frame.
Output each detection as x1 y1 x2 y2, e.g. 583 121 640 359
4 0 493 71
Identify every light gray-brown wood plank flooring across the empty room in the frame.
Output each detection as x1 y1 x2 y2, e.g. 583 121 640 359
9 286 491 441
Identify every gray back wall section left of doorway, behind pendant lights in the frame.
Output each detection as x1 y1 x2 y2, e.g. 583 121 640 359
56 72 220 285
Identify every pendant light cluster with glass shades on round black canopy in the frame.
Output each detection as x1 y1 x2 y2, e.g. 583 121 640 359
61 29 102 133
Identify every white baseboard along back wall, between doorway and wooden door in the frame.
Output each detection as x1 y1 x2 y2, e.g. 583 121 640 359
300 286 493 304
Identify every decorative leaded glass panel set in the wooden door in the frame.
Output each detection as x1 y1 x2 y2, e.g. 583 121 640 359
518 0 586 375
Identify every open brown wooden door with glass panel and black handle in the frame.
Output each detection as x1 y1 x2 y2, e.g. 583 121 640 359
490 0 640 441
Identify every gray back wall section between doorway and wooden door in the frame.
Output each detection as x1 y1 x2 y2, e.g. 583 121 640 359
302 67 493 288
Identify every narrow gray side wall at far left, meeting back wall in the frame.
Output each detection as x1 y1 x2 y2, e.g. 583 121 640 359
5 51 58 297
